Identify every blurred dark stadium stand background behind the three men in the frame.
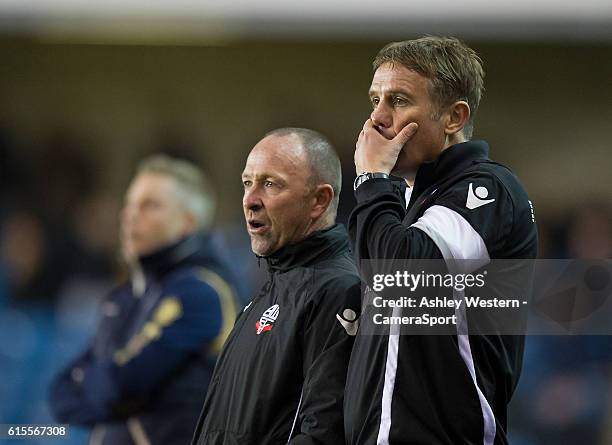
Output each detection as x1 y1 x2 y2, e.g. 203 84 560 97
0 0 612 445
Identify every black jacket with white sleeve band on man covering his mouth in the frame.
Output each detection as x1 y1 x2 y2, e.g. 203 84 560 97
345 141 537 445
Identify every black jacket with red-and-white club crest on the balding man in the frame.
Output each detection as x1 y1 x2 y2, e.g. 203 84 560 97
193 225 360 445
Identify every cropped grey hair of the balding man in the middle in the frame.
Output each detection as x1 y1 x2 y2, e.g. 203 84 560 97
264 127 342 219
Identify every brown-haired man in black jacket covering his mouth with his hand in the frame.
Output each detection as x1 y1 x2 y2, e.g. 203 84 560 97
344 37 537 445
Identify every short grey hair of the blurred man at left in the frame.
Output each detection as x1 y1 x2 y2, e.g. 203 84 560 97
136 154 216 230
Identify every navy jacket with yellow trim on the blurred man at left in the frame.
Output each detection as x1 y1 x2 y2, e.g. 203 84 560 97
50 235 236 445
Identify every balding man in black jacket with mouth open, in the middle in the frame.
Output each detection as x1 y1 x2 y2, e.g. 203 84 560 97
193 128 360 445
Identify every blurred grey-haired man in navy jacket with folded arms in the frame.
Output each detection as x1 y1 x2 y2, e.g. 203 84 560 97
50 155 236 445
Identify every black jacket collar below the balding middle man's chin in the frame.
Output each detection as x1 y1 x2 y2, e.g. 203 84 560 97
264 224 349 272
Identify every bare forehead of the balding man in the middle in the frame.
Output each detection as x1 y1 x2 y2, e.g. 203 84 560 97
243 134 308 177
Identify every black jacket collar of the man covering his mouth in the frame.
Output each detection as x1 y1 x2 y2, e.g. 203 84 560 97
410 140 489 204
